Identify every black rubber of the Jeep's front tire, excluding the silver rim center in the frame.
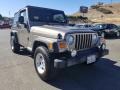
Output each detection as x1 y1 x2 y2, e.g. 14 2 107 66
34 46 57 81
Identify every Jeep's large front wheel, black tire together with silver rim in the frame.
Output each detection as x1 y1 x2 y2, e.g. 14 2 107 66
34 46 57 81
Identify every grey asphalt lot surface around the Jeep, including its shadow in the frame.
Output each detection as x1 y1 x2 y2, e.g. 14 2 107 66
0 30 120 90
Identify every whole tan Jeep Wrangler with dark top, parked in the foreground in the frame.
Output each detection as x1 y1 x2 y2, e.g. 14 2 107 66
10 6 109 81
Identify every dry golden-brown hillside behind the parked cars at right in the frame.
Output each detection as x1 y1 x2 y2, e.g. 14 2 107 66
73 3 120 24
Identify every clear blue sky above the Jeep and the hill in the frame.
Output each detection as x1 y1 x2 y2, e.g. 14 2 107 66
0 0 120 17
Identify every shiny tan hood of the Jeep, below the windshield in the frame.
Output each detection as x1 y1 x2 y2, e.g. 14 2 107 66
31 25 94 39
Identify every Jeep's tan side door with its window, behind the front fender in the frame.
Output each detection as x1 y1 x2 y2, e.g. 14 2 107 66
18 10 29 48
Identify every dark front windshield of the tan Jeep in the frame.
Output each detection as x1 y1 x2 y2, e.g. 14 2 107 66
29 8 67 23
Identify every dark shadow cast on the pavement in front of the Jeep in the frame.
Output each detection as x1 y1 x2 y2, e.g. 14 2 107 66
49 58 120 90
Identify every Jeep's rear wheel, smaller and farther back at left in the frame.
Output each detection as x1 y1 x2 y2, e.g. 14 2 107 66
10 36 20 53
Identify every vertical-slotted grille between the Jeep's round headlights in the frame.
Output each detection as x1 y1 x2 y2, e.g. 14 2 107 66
75 33 93 50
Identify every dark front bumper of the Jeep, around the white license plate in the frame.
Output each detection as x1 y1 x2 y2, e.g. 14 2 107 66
54 48 109 68
